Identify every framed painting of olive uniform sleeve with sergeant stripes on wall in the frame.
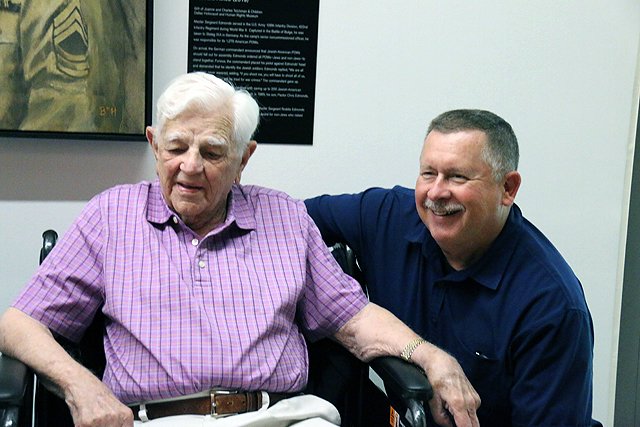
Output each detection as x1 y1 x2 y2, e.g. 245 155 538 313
0 0 153 143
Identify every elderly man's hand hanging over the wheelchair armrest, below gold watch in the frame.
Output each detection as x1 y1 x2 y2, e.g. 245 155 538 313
412 343 480 427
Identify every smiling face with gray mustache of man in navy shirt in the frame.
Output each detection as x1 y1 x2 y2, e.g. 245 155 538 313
415 130 519 269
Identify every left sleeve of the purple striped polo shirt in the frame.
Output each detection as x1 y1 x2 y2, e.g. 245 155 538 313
12 196 102 341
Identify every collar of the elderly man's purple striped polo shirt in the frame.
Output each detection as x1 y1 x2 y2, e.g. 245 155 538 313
147 179 256 233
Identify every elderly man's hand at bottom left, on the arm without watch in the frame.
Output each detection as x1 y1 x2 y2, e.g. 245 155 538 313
65 374 133 427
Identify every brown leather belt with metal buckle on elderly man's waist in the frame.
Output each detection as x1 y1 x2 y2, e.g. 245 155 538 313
129 390 296 421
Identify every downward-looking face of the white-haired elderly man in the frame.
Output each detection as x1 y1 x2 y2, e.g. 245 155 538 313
147 111 255 235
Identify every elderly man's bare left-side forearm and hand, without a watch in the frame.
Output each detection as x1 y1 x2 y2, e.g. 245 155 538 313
0 308 133 427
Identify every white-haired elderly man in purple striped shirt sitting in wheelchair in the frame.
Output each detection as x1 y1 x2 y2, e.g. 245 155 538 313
0 73 479 426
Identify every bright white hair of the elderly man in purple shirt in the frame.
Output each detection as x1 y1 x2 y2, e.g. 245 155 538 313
156 72 260 153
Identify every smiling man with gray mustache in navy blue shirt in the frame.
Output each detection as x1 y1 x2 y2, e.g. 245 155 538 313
306 110 593 426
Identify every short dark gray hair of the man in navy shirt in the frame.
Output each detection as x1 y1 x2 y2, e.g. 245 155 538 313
427 109 520 181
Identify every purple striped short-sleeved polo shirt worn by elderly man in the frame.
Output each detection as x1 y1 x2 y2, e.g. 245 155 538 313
14 181 367 402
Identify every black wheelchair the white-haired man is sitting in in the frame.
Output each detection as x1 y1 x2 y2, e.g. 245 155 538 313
0 230 433 427
